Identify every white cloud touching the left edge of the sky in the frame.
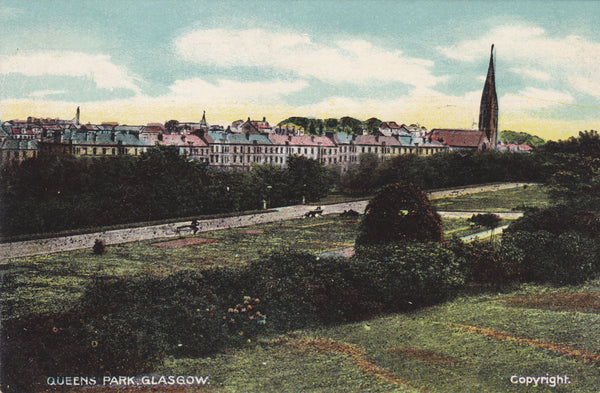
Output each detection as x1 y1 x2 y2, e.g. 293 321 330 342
0 52 139 93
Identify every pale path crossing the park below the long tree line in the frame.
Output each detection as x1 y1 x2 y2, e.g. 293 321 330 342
0 183 530 260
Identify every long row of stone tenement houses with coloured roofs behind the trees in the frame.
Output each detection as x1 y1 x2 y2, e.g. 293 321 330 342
0 113 450 168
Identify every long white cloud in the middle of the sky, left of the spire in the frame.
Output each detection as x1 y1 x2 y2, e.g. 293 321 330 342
174 29 446 87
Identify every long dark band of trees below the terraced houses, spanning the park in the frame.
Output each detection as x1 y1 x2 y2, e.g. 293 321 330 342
0 132 588 236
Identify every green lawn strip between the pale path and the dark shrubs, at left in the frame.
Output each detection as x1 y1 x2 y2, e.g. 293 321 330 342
0 216 358 318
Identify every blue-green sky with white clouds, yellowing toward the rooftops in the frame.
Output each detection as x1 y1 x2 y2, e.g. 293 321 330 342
0 0 600 140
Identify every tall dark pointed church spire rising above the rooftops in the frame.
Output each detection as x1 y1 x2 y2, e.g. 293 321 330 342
479 44 498 150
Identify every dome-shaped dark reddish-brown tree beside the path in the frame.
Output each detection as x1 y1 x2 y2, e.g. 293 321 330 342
356 183 442 245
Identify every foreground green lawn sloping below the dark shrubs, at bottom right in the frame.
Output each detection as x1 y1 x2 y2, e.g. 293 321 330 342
160 282 600 393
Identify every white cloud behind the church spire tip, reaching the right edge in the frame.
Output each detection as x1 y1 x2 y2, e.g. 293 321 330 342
438 25 600 97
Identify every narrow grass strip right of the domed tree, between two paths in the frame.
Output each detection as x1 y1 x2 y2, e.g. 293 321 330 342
432 185 551 212
